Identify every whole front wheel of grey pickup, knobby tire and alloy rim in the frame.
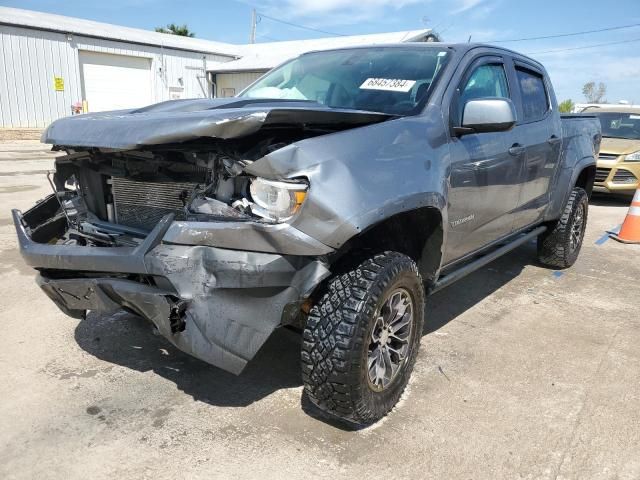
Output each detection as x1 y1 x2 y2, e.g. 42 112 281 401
302 252 425 425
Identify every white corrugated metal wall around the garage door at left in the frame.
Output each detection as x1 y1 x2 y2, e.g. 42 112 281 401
0 25 232 128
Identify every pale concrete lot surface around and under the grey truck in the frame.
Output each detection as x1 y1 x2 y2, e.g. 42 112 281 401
0 141 640 480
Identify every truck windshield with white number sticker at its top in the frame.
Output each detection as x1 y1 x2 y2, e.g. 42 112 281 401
240 46 450 115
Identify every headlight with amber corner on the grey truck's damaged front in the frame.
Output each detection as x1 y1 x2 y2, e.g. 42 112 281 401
249 178 309 222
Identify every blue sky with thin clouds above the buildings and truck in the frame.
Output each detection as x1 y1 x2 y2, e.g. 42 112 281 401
0 0 640 103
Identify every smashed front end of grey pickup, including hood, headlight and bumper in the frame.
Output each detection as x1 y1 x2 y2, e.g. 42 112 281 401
13 99 389 373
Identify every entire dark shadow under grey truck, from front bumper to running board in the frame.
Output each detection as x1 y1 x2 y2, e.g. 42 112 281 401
75 244 535 416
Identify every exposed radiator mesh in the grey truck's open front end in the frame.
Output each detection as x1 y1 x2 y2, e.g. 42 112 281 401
112 177 197 230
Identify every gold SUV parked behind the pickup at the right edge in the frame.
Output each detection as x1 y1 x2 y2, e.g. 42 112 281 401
583 106 640 193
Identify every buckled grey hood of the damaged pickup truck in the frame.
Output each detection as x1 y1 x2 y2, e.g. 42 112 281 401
41 98 391 150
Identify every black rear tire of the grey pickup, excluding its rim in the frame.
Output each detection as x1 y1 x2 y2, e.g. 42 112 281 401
538 187 589 268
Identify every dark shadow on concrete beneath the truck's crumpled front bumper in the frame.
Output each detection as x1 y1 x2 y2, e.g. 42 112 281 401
75 311 302 407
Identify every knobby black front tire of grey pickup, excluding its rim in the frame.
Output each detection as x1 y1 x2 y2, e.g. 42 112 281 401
302 252 425 425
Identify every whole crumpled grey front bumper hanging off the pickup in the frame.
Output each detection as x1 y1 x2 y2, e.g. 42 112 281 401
13 210 329 374
